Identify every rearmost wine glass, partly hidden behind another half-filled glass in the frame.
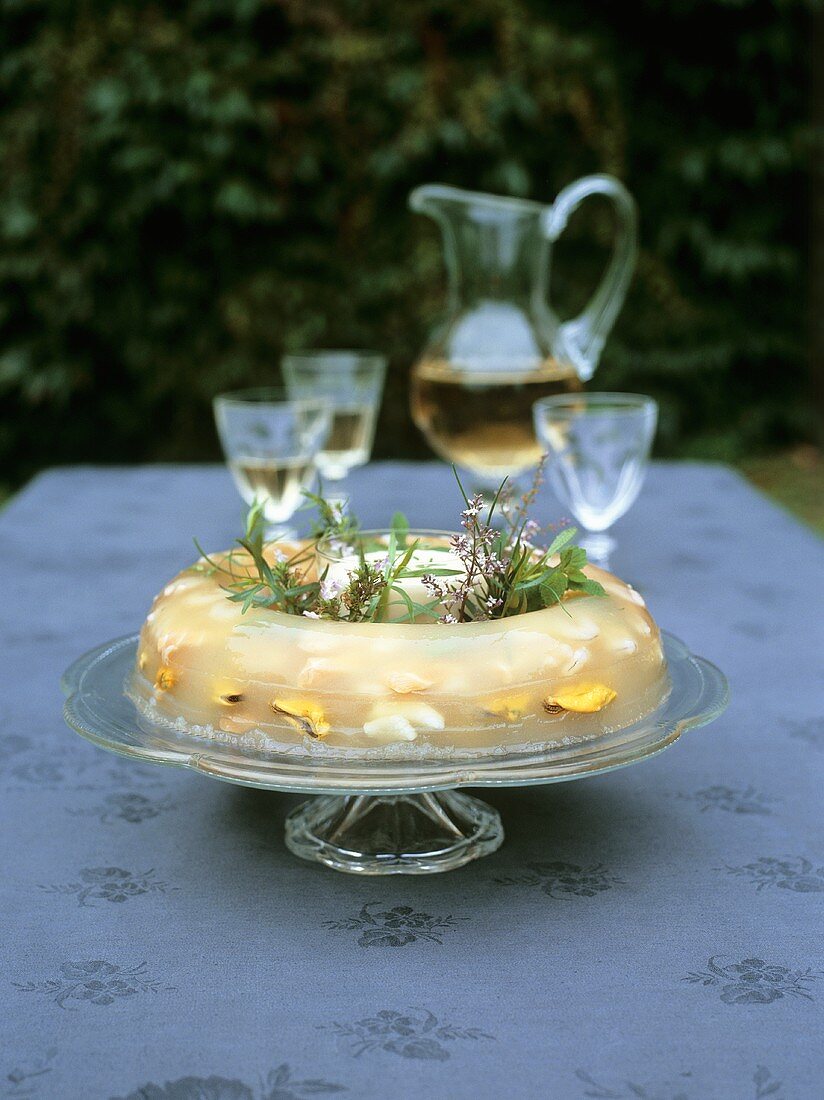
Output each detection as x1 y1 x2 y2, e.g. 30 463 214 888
281 350 386 495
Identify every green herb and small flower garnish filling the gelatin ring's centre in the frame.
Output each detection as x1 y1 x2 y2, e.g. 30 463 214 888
194 462 604 623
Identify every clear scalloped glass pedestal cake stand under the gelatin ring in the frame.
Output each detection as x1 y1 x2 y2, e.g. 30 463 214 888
63 634 728 875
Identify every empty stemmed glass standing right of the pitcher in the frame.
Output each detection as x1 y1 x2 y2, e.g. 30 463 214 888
532 393 658 569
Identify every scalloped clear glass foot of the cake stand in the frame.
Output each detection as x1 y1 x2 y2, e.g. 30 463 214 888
286 791 504 875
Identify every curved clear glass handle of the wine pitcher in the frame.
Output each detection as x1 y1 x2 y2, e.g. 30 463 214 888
541 176 638 382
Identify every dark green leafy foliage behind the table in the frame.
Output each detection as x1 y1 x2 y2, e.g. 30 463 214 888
0 0 811 482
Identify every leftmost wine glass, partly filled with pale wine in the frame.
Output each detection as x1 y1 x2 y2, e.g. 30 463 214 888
213 386 331 540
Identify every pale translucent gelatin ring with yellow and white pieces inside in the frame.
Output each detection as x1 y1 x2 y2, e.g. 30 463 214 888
128 541 669 756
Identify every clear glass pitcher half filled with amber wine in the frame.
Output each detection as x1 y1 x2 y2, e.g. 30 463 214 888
409 176 637 483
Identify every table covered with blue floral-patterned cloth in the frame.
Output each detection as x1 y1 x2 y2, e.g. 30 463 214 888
0 463 824 1100
